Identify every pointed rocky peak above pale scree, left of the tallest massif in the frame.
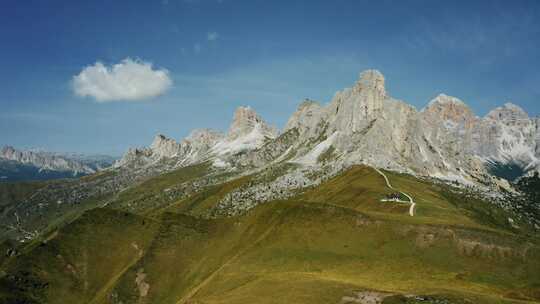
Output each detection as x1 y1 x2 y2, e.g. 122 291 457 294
227 106 277 140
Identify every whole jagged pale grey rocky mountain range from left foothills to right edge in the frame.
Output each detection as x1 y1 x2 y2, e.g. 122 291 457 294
116 70 540 185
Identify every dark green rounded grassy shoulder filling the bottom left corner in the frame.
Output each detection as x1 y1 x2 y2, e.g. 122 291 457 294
0 209 157 303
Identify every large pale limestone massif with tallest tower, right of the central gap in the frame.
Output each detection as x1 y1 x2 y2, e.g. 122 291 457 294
276 70 538 181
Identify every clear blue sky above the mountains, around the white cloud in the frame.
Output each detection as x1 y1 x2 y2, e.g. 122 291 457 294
0 0 540 155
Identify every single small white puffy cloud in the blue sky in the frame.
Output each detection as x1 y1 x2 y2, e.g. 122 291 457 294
73 58 172 102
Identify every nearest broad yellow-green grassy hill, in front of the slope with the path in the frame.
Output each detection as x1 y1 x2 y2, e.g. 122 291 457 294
106 201 540 303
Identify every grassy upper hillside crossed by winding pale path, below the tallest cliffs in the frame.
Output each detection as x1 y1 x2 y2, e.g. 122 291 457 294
298 166 511 231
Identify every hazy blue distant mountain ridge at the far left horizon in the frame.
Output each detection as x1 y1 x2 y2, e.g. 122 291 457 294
0 146 114 180
